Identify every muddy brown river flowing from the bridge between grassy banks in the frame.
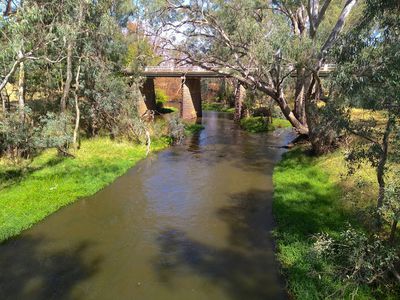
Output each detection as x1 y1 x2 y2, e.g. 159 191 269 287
0 113 294 300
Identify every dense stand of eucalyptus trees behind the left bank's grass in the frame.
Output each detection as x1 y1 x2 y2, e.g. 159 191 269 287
0 0 152 158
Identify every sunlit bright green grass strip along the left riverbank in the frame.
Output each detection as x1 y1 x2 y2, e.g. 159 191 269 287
0 138 168 241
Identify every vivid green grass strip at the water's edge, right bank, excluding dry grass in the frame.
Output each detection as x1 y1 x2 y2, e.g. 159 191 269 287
273 150 354 299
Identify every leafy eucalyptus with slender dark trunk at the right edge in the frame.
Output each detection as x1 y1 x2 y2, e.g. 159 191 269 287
332 0 400 236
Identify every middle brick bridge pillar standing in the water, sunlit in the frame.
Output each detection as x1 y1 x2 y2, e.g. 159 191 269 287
181 78 202 120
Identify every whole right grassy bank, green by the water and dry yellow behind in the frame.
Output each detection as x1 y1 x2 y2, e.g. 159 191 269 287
273 149 395 299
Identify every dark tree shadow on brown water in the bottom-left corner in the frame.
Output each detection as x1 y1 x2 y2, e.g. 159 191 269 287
0 237 102 300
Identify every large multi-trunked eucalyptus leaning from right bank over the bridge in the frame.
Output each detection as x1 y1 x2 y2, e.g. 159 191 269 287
147 0 357 153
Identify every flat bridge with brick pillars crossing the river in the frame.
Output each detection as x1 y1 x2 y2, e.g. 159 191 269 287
138 64 336 119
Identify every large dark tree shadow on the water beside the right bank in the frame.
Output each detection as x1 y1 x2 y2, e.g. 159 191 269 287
155 190 286 299
